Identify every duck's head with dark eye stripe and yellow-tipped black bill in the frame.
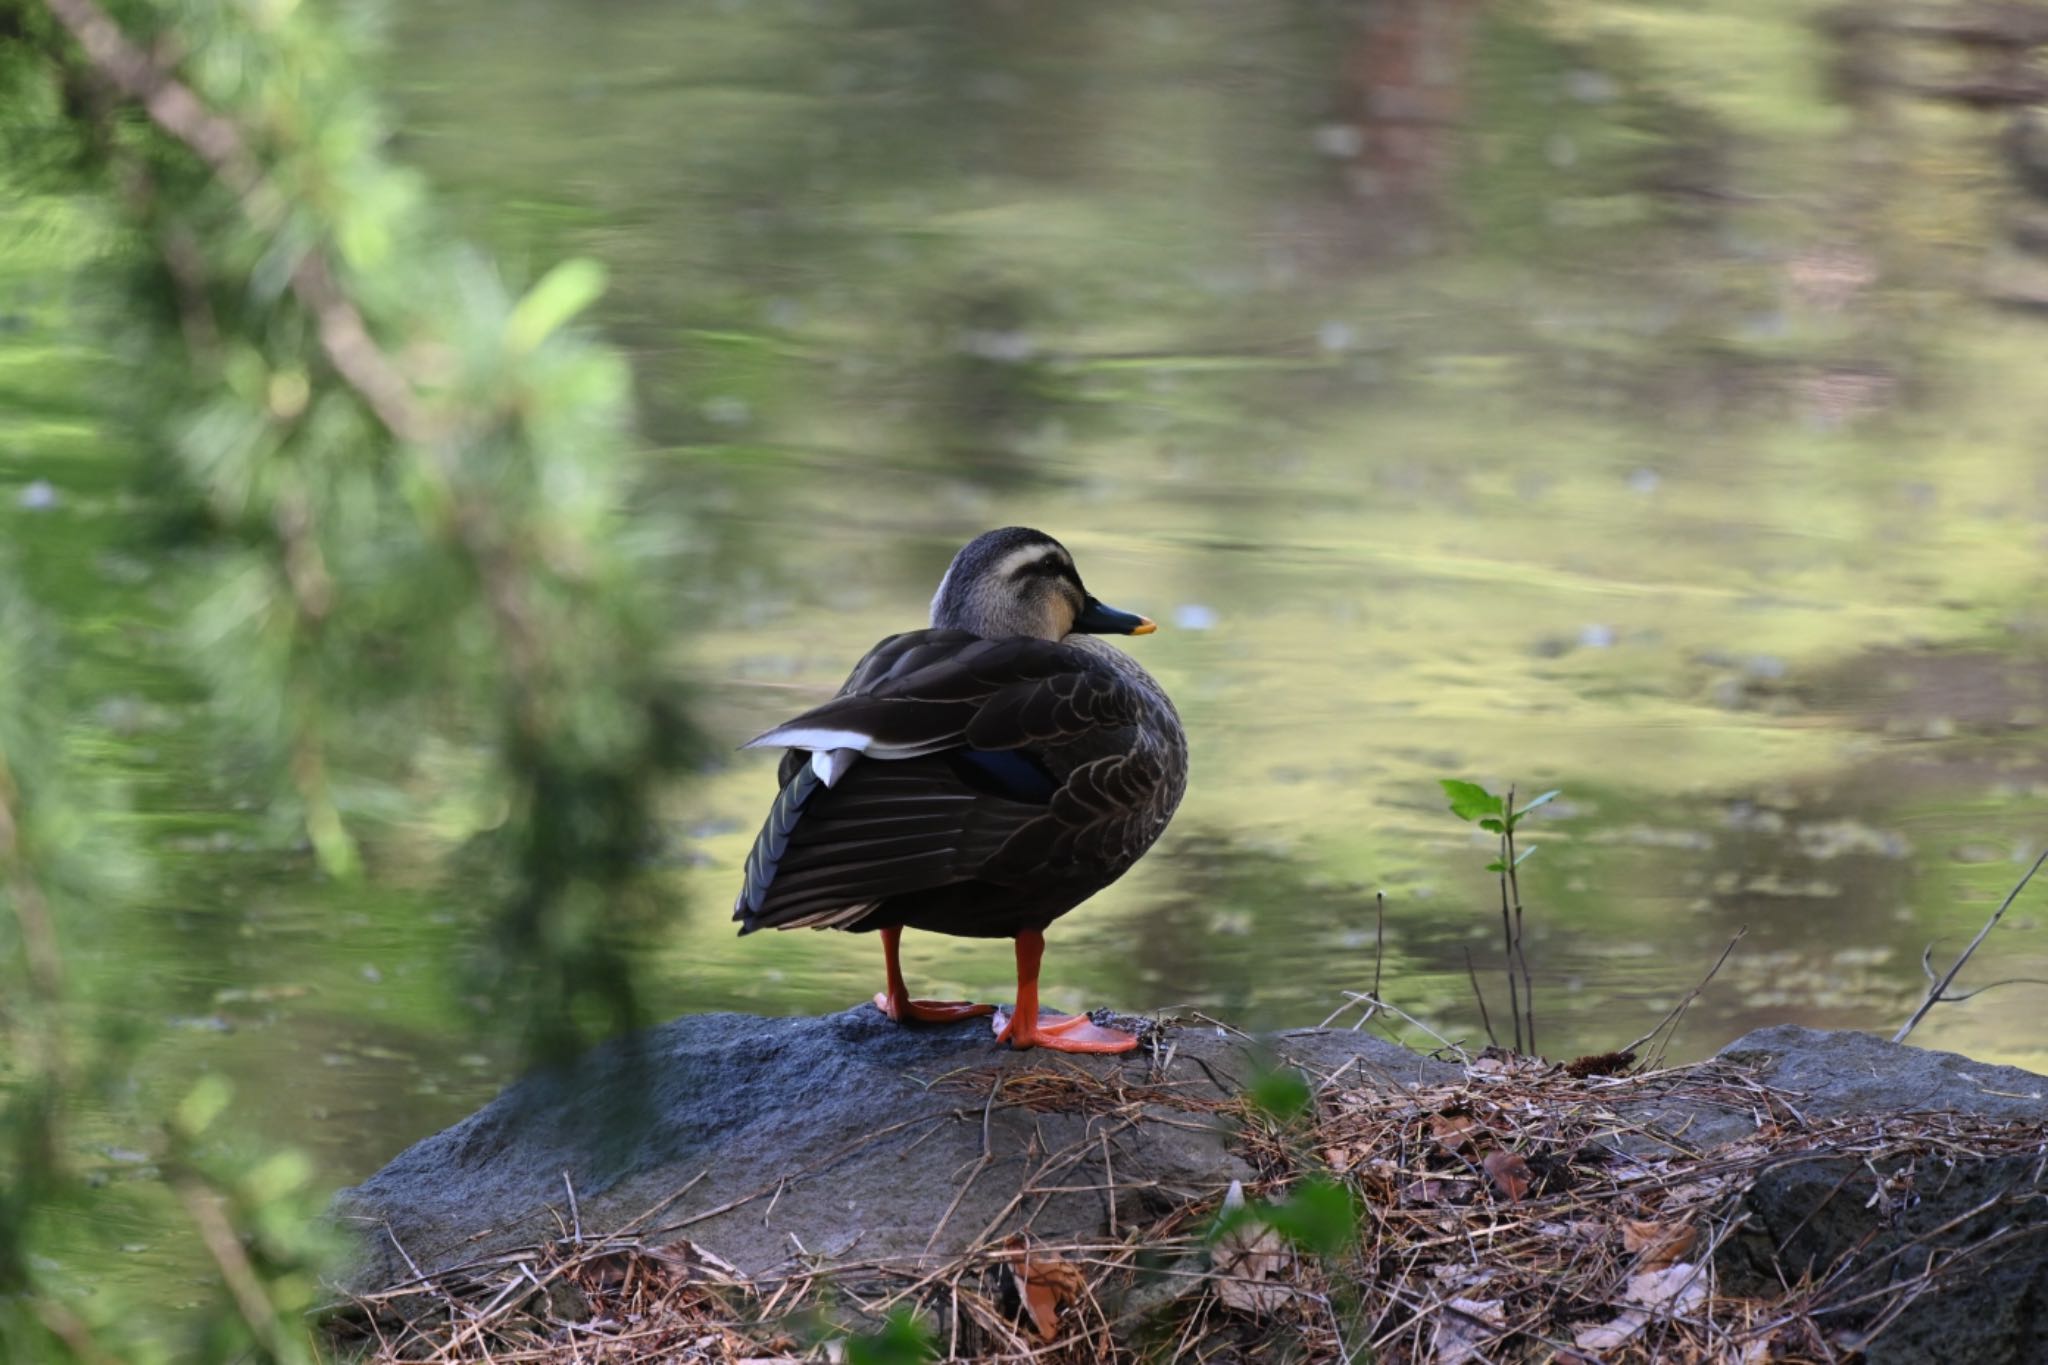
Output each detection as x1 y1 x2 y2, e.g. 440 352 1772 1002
932 526 1157 641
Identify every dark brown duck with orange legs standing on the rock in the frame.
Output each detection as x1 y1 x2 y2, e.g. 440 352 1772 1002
733 526 1188 1054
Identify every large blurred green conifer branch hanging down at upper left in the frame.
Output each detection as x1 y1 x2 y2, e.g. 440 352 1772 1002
8 4 696 1052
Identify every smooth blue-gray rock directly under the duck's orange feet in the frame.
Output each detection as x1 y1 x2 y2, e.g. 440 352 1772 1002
336 1007 1456 1289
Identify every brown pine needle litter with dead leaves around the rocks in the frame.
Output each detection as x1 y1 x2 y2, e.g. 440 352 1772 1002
328 1054 2048 1365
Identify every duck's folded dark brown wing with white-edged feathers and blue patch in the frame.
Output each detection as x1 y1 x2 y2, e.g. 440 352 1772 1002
733 630 1159 933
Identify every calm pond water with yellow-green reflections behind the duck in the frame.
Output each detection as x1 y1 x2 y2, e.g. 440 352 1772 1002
0 0 2048 1326
